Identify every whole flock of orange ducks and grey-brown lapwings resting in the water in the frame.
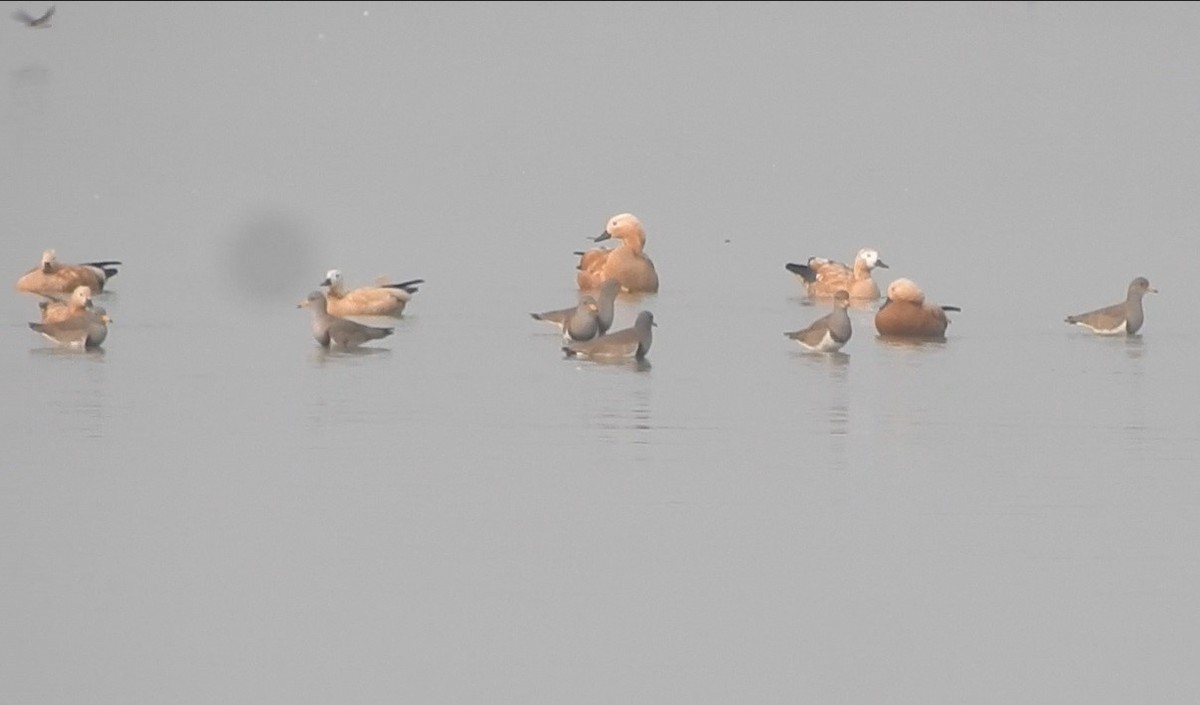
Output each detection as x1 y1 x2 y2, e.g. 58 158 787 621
17 213 1157 361
